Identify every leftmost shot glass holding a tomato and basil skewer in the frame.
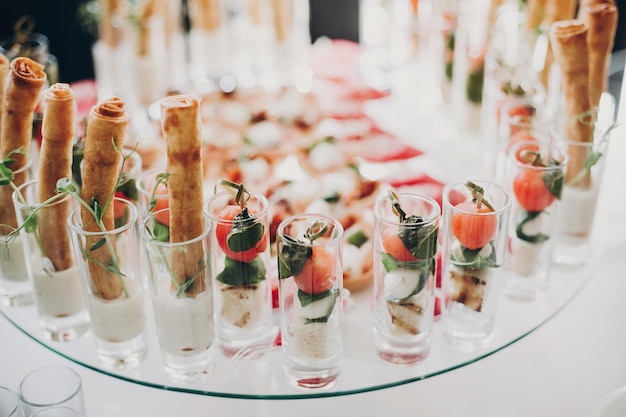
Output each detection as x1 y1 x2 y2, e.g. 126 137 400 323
205 191 275 356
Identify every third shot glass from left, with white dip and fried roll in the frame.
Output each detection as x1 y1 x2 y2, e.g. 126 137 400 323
69 198 148 369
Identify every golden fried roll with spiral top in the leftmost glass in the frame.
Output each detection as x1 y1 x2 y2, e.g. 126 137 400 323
0 57 46 233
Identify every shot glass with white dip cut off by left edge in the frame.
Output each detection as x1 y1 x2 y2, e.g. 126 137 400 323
0 160 34 306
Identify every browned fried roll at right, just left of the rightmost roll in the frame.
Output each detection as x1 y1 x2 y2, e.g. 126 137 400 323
550 19 593 187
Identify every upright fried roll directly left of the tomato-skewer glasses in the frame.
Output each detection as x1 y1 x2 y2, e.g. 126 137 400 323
161 95 206 297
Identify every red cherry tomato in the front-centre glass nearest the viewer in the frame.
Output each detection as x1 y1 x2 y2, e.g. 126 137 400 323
293 246 337 294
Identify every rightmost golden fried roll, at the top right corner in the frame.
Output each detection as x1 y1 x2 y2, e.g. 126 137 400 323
580 3 618 107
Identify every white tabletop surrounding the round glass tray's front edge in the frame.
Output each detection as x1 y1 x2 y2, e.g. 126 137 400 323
0 59 626 417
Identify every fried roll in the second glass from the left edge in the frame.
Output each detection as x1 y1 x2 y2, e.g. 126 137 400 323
37 83 76 271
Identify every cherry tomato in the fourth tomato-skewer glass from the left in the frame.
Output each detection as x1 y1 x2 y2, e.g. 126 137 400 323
451 201 497 249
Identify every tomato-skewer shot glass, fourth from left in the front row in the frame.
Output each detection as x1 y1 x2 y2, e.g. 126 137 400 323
441 181 511 350
